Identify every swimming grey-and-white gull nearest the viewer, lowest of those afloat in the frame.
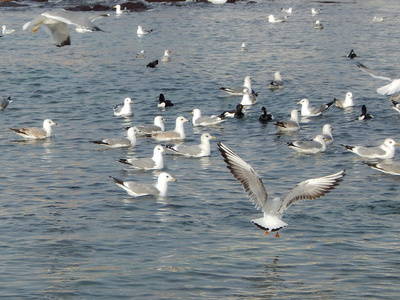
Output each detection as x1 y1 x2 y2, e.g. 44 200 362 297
110 172 176 197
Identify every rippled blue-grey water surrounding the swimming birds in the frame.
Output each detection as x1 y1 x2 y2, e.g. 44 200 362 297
0 0 400 299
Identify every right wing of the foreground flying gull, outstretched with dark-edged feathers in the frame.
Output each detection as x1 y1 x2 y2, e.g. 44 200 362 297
278 170 345 213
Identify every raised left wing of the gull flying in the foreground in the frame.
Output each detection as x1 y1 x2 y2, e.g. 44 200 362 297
218 142 268 208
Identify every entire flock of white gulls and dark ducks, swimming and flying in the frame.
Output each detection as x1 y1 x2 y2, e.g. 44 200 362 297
0 1 400 236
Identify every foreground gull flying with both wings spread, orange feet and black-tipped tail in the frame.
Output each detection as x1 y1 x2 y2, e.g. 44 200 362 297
218 142 345 237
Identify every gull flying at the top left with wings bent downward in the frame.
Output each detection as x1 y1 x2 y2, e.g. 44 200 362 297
22 9 110 47
